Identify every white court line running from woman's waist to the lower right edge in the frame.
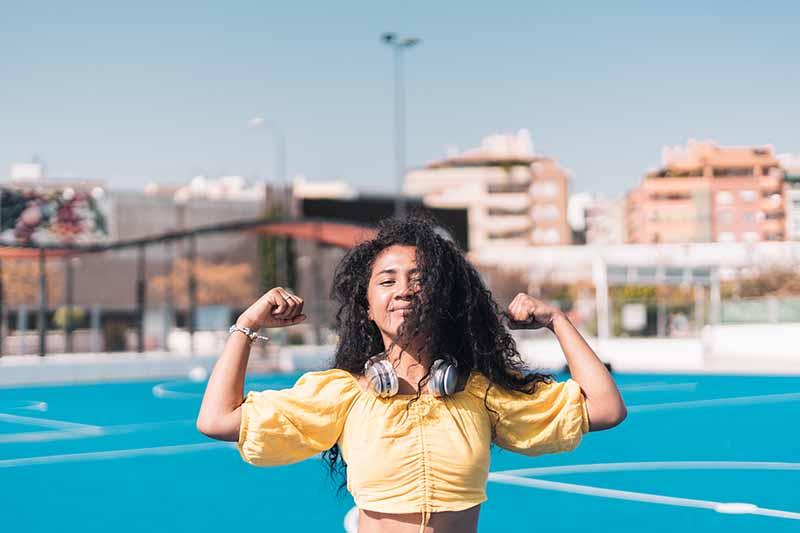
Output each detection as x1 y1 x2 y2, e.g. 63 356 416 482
489 473 800 520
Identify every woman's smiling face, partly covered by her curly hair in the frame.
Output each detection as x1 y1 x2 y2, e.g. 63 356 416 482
367 245 419 346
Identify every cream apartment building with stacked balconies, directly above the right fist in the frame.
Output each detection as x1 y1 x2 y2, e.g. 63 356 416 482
404 130 572 251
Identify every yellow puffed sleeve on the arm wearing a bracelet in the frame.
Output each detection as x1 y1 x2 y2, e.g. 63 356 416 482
236 369 360 466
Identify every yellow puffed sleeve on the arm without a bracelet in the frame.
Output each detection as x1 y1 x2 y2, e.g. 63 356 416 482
478 379 589 456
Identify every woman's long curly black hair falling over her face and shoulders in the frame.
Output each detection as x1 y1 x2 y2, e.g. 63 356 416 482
324 212 552 490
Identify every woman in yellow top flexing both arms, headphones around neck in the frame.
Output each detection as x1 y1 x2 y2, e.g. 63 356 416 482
197 217 626 533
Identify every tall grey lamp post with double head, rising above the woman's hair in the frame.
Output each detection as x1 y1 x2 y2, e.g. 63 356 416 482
381 33 422 217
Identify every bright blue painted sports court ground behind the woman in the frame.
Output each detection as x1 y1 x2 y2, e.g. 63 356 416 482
0 375 800 533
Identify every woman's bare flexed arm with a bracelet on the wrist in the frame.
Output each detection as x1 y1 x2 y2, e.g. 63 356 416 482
197 287 306 442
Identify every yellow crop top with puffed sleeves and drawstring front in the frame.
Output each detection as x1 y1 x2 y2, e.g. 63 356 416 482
237 369 589 524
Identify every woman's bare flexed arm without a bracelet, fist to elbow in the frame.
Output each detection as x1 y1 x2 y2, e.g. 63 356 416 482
509 293 627 431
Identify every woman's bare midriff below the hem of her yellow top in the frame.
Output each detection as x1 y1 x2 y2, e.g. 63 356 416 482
358 505 481 533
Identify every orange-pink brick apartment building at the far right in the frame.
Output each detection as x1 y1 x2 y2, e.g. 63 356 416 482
627 140 786 243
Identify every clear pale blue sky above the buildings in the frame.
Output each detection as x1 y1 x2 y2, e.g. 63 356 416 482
0 0 800 195
